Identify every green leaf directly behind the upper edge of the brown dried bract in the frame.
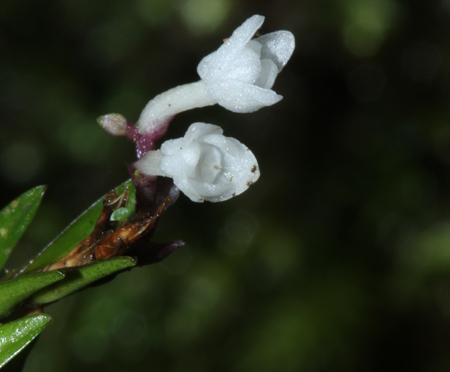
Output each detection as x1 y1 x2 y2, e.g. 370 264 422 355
24 180 132 272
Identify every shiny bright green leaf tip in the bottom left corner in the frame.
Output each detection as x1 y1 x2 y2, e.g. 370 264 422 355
0 314 52 368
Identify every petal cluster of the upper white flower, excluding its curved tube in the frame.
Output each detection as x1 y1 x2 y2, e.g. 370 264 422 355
197 15 295 112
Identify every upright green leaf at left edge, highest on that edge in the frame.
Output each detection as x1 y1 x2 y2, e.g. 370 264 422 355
0 186 47 268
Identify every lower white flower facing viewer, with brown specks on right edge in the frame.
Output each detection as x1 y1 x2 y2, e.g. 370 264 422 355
135 123 260 202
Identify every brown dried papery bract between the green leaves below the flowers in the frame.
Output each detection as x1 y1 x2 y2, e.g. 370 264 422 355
42 187 171 271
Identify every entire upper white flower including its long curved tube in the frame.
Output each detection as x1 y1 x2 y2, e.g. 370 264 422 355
136 15 295 133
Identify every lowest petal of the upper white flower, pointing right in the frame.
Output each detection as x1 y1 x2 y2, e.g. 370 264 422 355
207 80 283 113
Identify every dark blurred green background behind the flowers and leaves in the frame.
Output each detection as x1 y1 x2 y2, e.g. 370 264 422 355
0 0 450 372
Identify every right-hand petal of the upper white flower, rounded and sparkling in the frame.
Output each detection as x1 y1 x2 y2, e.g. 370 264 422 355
254 31 295 72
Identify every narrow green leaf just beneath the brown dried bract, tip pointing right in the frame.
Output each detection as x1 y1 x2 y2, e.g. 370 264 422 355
31 256 137 305
